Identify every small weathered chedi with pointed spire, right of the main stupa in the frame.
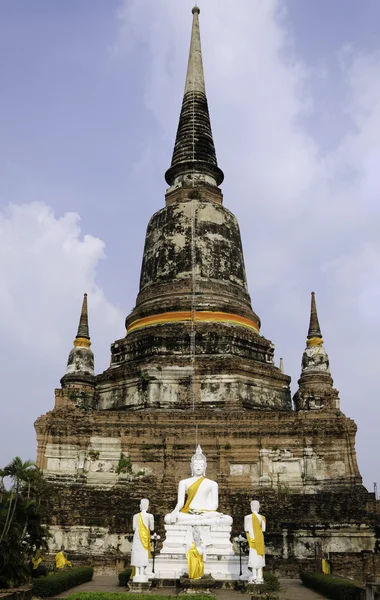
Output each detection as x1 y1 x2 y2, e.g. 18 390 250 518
293 292 339 410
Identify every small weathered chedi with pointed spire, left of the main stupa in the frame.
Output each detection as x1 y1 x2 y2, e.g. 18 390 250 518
61 294 95 387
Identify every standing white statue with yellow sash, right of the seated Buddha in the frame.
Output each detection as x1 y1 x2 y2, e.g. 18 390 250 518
244 500 266 583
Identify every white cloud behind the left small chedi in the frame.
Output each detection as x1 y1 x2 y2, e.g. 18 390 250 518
0 202 123 462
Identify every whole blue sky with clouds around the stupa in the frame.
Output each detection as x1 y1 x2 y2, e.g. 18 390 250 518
0 0 380 490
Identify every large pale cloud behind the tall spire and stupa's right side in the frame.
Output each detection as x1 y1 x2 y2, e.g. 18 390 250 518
119 0 380 483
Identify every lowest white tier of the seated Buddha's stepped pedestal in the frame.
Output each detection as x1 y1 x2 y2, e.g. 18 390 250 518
154 553 251 581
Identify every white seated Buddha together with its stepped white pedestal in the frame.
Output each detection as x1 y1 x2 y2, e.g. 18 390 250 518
155 445 246 580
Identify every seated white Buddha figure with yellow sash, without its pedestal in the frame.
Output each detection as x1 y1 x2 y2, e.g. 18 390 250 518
165 444 232 526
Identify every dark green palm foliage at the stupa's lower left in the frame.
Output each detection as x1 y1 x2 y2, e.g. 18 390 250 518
0 456 49 588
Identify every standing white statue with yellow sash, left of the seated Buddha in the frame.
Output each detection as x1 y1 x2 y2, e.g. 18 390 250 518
131 498 154 583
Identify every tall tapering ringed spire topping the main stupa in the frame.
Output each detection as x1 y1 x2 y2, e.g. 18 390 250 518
165 6 224 186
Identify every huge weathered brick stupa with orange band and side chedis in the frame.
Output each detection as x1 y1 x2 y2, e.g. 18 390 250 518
35 7 380 579
